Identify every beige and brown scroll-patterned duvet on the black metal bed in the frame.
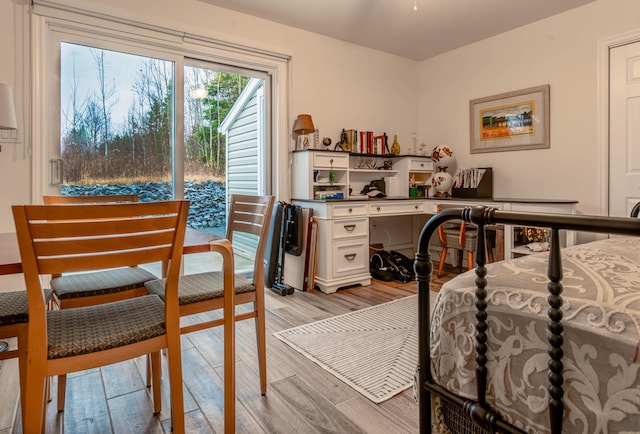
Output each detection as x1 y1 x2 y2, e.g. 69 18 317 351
431 238 640 433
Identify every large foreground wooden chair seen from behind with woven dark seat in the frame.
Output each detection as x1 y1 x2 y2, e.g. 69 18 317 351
12 201 189 433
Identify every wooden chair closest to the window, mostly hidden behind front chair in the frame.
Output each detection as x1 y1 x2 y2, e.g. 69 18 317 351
42 194 158 309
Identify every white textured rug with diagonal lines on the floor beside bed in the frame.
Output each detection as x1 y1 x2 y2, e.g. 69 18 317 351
274 295 418 403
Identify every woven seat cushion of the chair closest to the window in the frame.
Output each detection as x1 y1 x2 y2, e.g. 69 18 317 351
51 267 158 300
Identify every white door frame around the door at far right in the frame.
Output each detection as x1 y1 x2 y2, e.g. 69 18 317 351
596 30 640 215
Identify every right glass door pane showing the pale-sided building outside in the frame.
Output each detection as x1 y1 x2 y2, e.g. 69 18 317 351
184 63 264 236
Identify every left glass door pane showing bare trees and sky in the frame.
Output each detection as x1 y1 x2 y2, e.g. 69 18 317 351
59 42 175 201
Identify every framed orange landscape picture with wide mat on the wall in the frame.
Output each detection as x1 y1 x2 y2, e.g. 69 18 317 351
469 84 549 154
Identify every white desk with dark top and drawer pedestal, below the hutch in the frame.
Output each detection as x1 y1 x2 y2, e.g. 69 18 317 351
292 198 577 293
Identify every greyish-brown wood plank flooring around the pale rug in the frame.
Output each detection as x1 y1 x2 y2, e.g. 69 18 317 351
0 269 456 434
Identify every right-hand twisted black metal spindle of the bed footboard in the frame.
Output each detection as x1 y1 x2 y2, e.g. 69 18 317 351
547 228 564 434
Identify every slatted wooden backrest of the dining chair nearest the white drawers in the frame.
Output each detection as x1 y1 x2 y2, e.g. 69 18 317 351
227 194 275 282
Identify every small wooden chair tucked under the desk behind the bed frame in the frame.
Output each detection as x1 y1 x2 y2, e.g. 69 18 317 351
436 204 496 277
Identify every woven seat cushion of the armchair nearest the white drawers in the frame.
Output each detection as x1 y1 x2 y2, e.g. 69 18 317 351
144 271 256 306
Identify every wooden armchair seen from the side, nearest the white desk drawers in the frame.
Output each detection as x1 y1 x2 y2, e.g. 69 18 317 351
145 195 274 432
